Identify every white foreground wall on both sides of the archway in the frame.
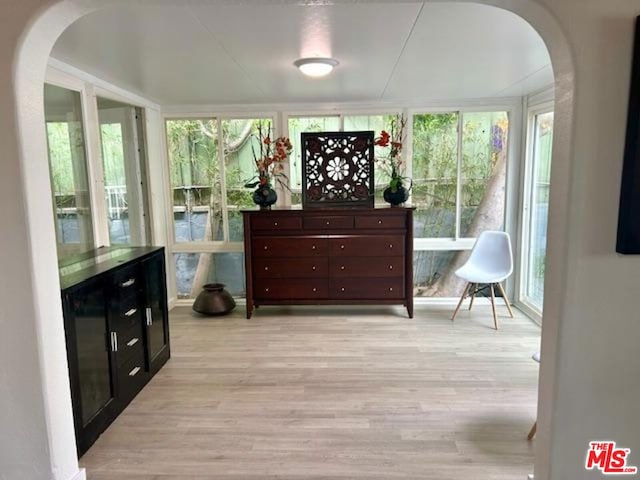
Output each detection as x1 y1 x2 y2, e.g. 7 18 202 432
0 0 640 480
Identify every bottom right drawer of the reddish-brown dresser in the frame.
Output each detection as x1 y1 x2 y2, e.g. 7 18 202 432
329 277 404 300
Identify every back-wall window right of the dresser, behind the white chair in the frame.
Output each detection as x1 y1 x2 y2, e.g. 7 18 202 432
412 111 509 297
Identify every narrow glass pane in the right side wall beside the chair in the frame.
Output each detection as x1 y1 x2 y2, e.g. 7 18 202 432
521 112 553 313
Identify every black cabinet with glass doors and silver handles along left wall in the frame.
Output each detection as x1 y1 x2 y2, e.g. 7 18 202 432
61 247 170 455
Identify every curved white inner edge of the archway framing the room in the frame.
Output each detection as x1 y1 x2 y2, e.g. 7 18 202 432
6 0 574 478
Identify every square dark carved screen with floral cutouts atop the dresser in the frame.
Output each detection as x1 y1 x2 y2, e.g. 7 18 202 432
301 131 375 208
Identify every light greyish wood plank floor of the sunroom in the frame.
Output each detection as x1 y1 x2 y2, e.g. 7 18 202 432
81 306 540 480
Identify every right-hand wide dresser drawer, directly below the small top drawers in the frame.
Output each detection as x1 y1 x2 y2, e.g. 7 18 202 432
329 235 405 257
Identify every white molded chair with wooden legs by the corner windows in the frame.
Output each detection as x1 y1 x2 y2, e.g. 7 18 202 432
451 230 513 330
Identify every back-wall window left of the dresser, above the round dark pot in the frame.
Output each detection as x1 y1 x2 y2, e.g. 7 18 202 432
166 117 273 298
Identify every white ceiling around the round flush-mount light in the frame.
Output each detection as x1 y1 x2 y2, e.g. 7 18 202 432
52 3 553 105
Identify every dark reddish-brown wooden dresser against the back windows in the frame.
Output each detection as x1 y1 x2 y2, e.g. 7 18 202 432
242 207 413 318
